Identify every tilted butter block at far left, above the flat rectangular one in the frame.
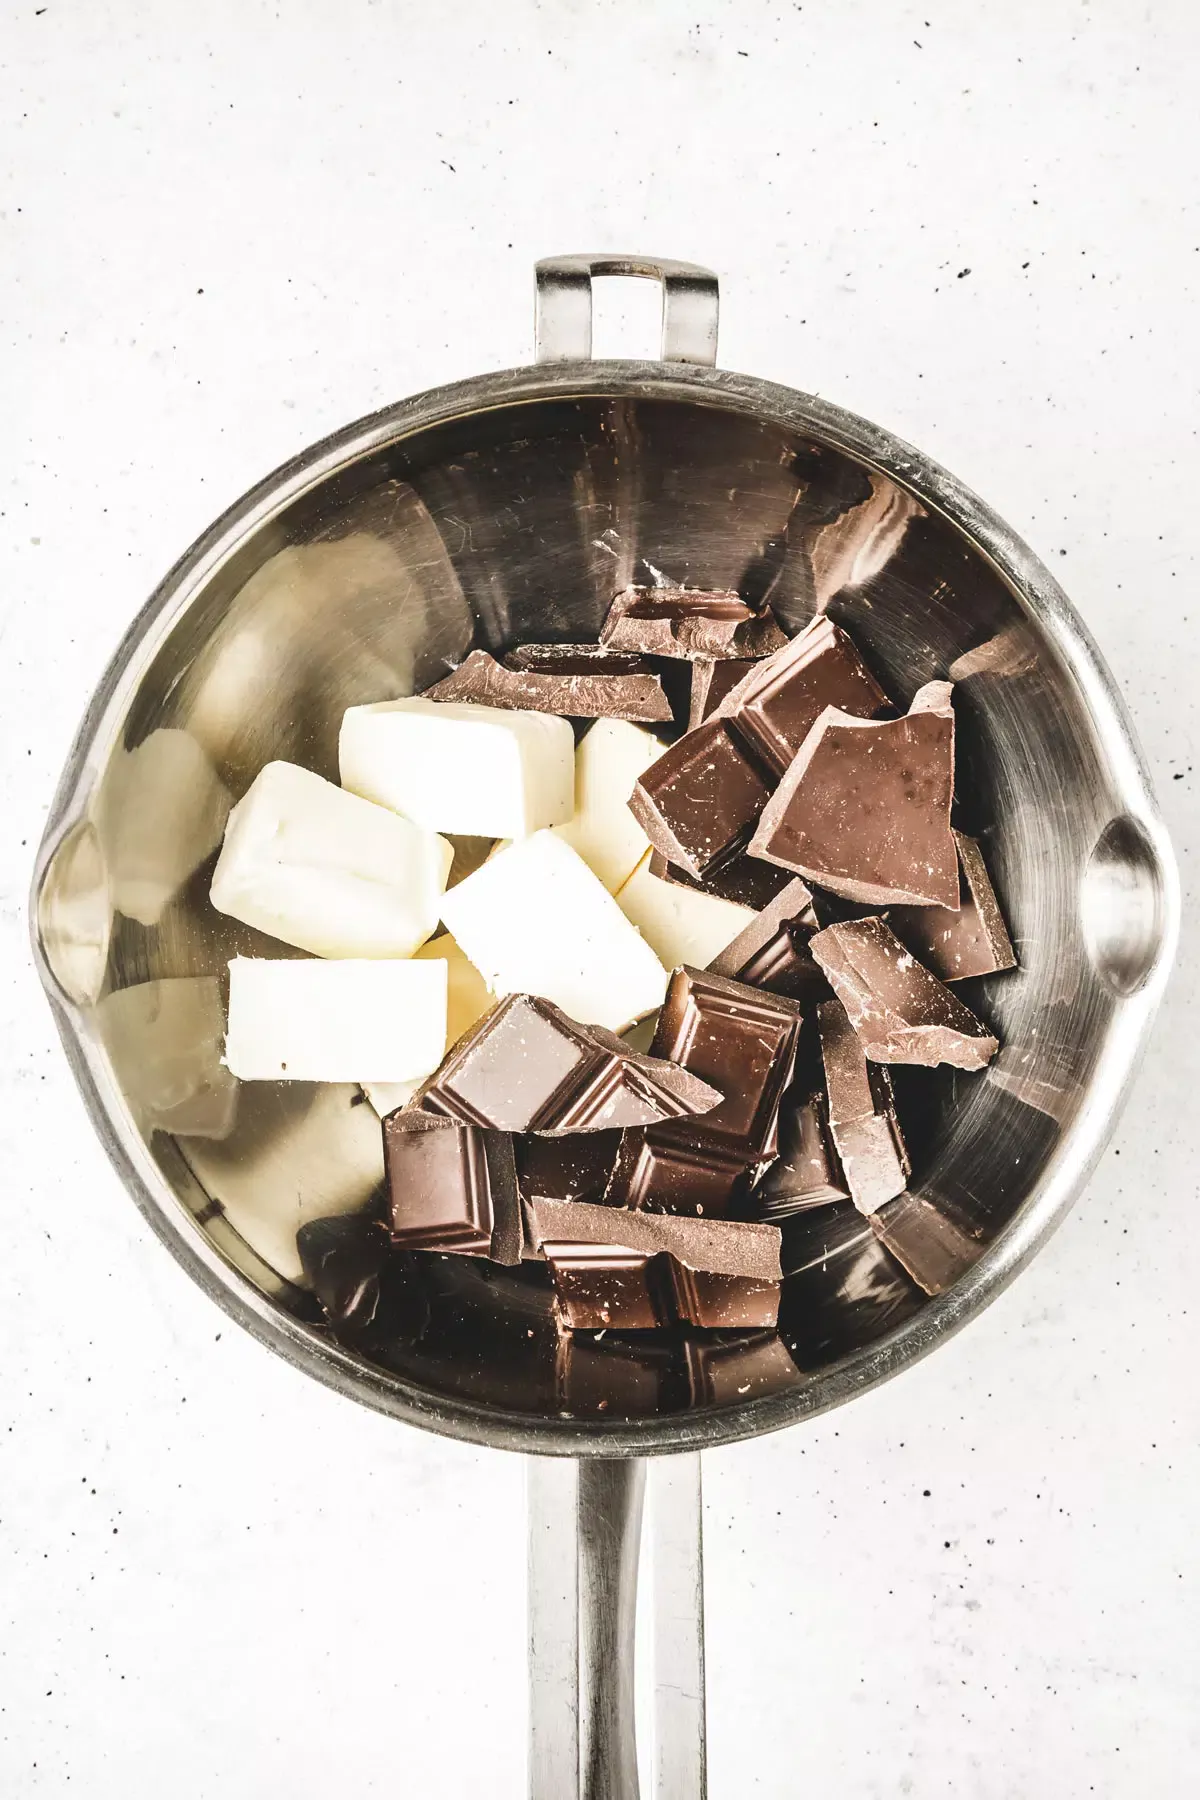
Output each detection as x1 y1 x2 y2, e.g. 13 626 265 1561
212 763 453 958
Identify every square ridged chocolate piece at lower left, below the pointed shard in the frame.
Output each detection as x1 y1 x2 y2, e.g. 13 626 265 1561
383 1109 522 1264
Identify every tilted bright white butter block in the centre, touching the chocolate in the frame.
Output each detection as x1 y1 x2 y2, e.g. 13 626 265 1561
443 832 667 1031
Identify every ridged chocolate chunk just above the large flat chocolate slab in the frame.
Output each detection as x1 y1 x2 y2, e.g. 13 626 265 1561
716 617 889 776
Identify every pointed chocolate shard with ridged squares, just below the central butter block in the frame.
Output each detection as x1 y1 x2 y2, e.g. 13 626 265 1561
412 994 721 1132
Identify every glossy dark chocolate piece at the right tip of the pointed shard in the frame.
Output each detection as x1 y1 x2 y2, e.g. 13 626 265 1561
653 968 801 1166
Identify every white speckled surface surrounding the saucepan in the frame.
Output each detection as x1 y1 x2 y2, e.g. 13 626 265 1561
0 0 1200 1800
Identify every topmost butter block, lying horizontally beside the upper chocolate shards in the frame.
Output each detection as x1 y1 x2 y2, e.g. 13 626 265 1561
338 698 576 837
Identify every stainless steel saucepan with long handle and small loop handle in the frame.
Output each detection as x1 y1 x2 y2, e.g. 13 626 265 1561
34 256 1178 1800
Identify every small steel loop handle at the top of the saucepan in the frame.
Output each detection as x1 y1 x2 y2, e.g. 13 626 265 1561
534 256 720 364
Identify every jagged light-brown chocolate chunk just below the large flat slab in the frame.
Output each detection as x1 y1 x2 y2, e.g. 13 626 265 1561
808 918 1000 1069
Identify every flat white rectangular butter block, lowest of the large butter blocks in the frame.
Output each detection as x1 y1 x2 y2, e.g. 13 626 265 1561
225 956 446 1084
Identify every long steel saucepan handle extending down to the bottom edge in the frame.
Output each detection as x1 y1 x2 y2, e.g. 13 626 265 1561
529 1456 707 1800
